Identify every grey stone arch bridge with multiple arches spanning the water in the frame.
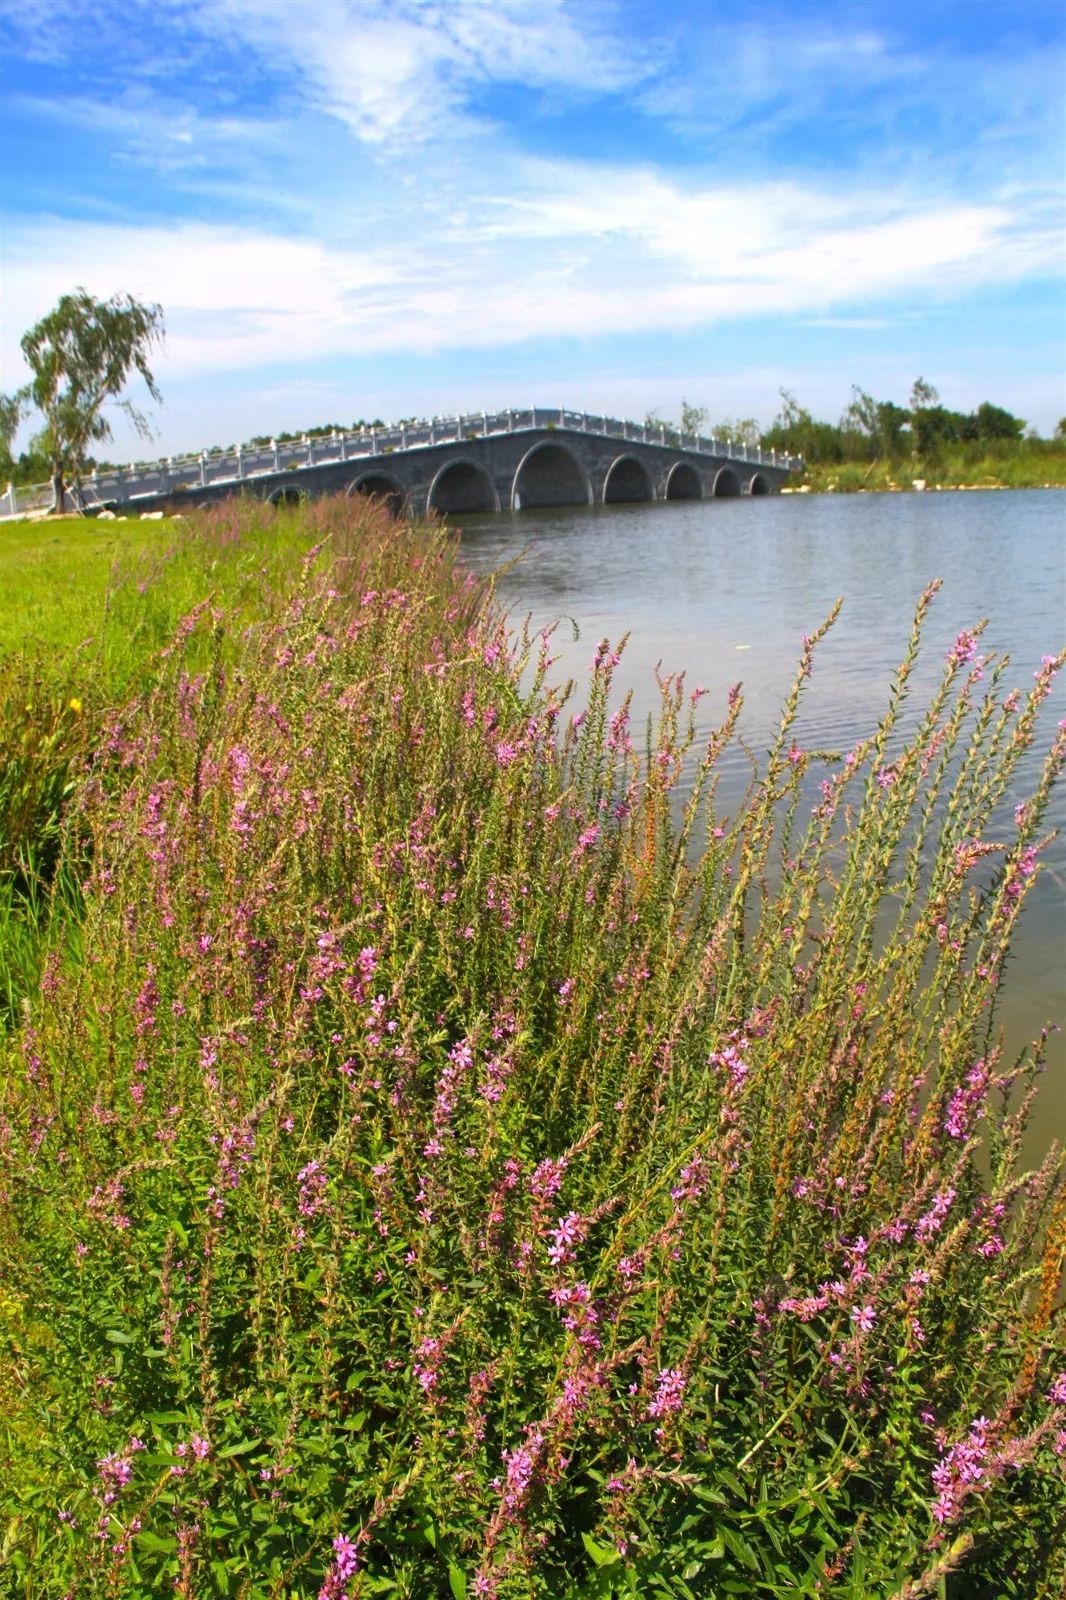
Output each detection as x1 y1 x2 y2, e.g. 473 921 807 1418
16 408 802 515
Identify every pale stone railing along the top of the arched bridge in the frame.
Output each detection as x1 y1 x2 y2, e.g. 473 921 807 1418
0 406 802 515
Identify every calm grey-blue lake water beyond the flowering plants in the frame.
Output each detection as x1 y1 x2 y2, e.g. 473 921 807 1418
463 490 1066 1157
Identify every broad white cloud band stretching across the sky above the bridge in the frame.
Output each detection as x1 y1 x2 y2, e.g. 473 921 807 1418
3 163 1058 396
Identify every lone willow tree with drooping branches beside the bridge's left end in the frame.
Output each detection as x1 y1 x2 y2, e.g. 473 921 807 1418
18 288 163 510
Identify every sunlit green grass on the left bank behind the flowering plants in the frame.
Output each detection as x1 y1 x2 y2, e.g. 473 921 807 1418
0 501 328 1027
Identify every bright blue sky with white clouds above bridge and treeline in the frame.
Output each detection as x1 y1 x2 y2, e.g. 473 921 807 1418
0 0 1066 454
